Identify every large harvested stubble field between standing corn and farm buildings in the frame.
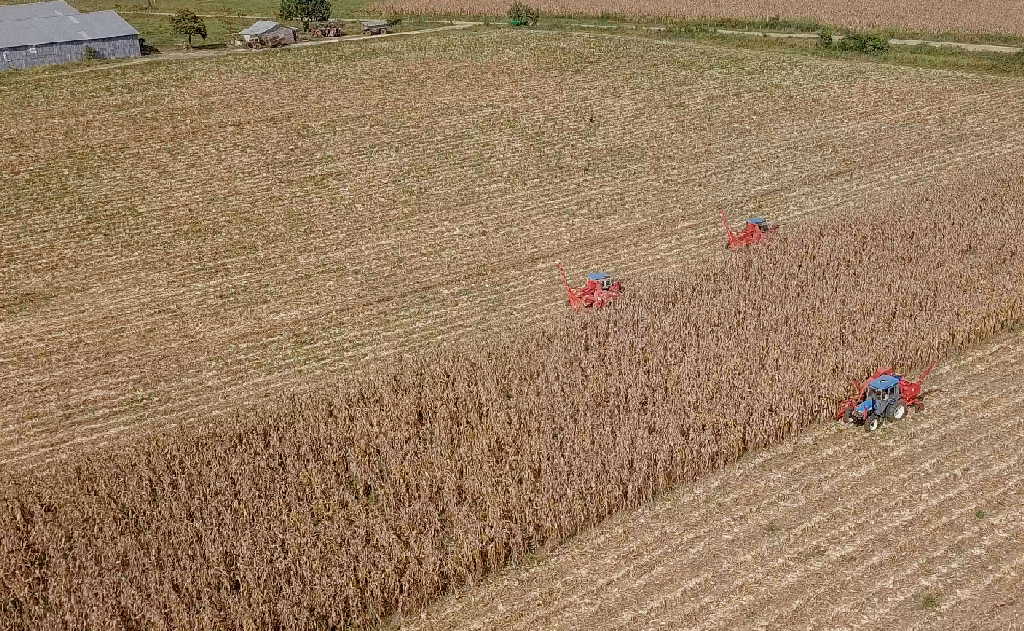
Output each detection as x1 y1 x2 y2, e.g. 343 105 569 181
0 32 1024 468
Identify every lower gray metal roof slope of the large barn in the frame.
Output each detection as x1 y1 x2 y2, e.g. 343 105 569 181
0 11 138 48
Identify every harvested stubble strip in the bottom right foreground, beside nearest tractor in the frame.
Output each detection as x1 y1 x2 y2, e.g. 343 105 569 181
401 335 1024 631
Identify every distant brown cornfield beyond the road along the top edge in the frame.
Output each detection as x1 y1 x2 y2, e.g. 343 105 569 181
380 0 1024 36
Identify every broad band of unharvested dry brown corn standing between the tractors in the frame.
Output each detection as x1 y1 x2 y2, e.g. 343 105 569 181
0 165 1024 629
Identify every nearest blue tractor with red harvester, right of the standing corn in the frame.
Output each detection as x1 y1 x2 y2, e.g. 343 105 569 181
836 364 935 431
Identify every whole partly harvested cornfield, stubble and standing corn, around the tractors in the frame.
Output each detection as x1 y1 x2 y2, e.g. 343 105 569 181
0 23 1024 629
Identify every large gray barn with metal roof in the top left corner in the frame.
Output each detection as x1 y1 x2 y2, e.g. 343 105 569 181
0 0 141 71
